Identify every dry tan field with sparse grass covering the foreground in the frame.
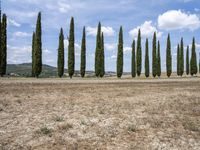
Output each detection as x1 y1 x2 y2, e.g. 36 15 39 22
0 78 200 150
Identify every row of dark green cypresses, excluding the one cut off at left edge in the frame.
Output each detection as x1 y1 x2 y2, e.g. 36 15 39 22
32 12 197 78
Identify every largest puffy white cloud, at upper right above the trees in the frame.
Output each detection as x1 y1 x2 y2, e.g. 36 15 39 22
158 10 200 31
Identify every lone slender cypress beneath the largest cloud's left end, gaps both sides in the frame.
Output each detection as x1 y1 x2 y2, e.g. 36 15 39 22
166 34 172 78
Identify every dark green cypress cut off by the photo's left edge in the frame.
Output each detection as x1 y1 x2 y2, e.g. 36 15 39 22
0 14 7 76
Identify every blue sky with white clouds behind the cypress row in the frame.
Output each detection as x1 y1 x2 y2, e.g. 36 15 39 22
2 0 200 72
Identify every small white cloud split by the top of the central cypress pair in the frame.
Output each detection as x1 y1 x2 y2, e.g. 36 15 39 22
86 26 115 36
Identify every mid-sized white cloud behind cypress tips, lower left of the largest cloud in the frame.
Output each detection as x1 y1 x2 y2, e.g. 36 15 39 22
129 21 162 38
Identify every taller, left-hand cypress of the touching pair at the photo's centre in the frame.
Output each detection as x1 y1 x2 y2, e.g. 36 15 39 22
95 22 102 77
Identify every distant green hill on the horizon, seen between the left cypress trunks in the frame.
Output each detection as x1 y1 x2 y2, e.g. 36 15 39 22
7 63 115 77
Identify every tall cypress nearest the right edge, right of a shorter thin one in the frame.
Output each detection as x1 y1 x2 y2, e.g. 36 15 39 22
190 38 197 76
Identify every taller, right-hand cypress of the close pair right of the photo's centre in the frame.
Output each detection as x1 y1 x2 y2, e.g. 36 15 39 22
136 29 142 76
